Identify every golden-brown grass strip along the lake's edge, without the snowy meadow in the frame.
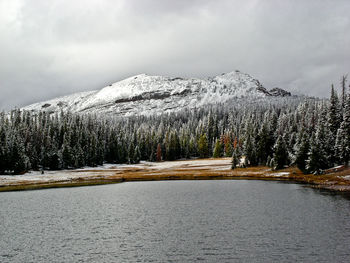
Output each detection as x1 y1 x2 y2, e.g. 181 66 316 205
0 159 350 192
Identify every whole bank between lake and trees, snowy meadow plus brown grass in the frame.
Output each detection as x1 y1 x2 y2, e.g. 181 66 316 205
0 158 350 193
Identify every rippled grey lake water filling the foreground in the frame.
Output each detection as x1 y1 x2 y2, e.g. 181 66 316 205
0 181 350 262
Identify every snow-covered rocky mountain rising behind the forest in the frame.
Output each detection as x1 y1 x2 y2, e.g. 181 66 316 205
22 70 290 115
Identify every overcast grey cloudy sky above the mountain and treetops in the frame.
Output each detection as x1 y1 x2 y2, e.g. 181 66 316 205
0 0 350 110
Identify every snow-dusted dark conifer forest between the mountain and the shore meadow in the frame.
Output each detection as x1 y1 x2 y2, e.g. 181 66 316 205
0 76 350 174
